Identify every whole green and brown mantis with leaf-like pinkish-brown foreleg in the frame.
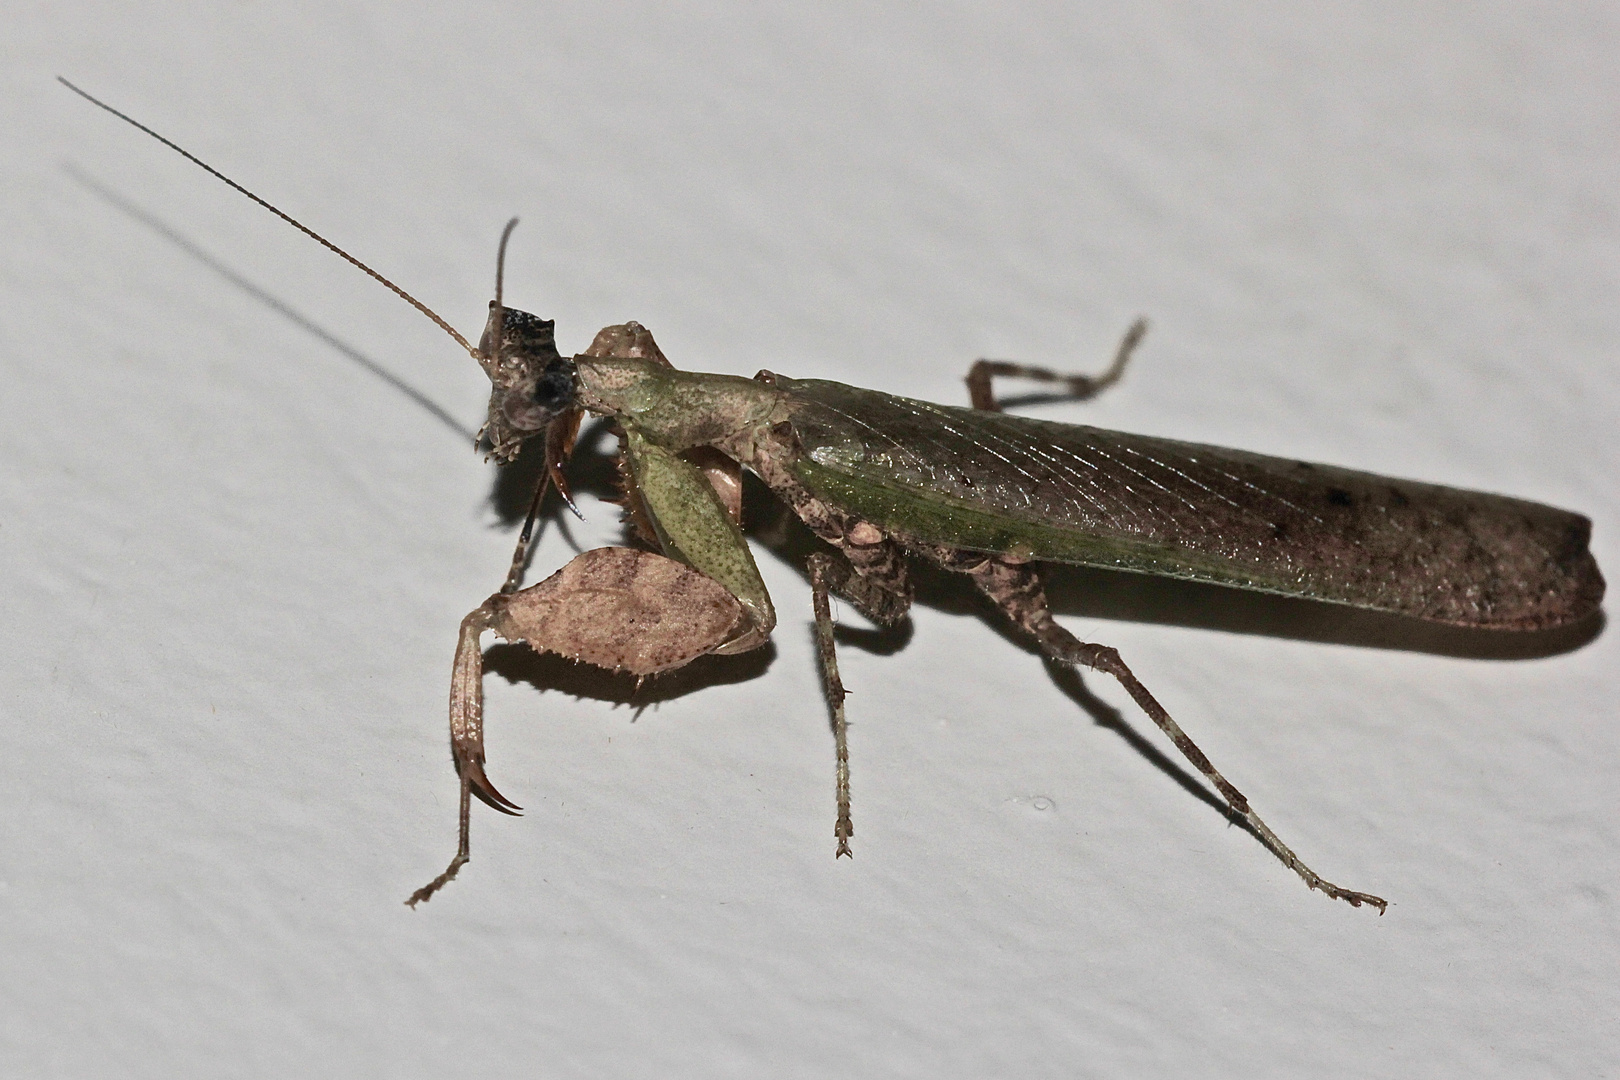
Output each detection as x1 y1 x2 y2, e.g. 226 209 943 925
62 79 1604 912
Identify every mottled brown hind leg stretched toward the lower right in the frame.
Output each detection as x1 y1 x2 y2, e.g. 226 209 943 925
930 549 1387 915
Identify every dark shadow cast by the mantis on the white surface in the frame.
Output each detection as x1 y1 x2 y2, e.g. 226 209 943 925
76 164 1605 761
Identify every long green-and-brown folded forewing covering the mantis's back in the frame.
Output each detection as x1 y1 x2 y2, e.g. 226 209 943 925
776 377 1604 630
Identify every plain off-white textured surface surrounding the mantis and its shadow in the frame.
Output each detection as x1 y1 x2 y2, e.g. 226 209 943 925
0 3 1620 1078
